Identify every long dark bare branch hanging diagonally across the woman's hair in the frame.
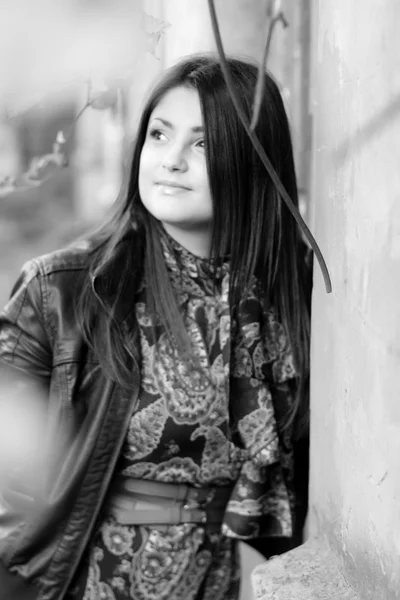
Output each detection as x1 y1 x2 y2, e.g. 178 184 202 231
208 0 332 294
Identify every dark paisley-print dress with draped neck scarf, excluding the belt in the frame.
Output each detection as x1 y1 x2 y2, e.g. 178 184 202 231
68 236 295 600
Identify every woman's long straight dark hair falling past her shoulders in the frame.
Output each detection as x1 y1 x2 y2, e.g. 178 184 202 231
77 55 310 432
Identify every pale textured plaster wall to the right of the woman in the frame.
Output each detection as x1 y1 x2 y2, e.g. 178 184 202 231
310 0 400 600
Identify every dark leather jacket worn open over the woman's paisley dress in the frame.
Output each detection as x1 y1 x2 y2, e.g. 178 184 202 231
0 243 139 600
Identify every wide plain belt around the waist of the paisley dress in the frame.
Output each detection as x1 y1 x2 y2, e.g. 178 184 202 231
106 476 232 529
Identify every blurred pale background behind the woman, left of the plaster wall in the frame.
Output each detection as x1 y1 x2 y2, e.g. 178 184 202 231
0 0 310 305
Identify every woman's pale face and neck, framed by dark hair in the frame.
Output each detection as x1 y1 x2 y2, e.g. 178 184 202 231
139 87 212 249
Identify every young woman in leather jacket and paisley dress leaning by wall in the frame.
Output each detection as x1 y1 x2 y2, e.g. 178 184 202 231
0 56 310 600
